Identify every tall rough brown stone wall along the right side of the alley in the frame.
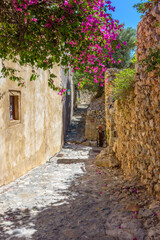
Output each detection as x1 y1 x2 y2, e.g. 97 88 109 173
105 4 160 199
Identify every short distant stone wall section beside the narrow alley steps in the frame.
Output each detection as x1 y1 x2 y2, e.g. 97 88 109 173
85 98 106 144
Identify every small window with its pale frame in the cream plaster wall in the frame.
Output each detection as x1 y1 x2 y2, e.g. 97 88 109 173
9 91 20 122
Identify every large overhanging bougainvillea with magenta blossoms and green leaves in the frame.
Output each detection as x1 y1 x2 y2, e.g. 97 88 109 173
0 0 126 94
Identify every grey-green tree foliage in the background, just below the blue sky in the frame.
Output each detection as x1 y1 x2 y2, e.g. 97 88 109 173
106 27 136 69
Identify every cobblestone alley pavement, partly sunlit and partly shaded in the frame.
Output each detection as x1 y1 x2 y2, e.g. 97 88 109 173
0 106 160 240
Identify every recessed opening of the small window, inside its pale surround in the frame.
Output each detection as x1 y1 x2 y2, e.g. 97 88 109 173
9 95 20 121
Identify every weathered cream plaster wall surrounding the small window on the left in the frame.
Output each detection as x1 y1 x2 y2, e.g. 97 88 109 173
0 60 62 185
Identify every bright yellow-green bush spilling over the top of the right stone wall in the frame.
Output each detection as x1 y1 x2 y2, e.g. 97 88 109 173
113 68 136 100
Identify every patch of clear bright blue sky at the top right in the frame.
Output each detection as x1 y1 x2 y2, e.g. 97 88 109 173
111 0 141 29
